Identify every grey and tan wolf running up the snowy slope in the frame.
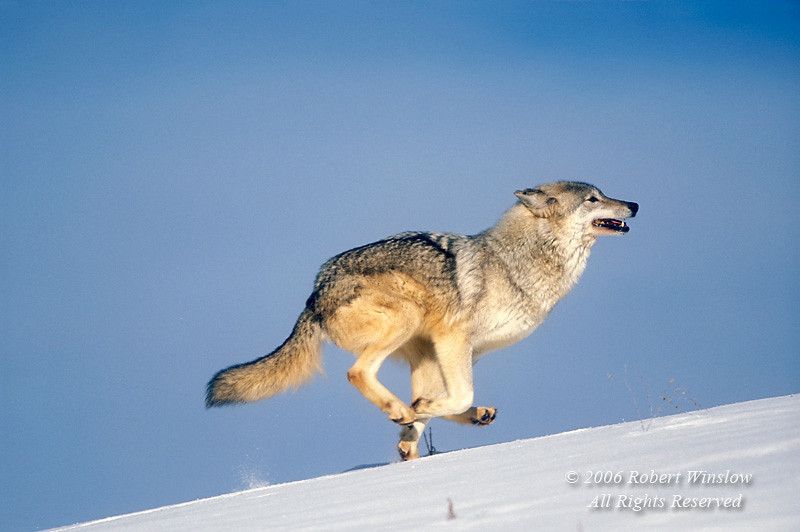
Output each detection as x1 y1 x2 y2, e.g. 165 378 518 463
206 181 639 460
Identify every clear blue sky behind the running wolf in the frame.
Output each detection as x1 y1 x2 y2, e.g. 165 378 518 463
0 0 800 529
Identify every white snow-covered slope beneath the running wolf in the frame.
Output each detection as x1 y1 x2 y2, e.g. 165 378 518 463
56 395 800 530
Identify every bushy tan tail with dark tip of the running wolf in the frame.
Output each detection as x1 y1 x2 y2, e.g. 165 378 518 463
206 309 322 408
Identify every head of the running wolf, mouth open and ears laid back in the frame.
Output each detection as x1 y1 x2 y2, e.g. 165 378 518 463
514 181 639 236
